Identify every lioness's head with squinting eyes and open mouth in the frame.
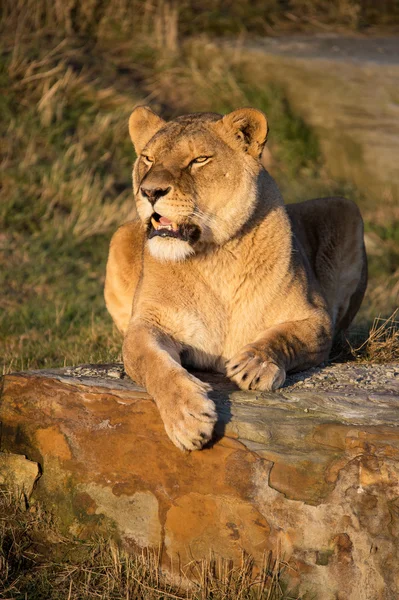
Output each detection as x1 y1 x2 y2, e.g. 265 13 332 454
129 106 267 261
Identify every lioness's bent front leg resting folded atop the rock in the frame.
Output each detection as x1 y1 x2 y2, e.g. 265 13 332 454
226 312 332 391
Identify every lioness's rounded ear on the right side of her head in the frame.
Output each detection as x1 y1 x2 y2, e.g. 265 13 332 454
218 108 268 158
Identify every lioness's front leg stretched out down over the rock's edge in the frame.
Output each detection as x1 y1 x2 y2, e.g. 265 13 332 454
123 320 217 450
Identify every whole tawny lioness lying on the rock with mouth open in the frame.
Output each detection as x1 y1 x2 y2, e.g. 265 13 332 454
105 107 367 450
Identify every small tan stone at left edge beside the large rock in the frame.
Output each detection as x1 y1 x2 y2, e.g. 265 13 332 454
0 452 40 498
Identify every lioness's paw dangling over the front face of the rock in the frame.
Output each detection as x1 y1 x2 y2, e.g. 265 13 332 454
157 375 217 450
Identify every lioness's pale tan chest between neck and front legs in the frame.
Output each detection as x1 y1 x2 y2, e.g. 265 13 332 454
136 246 288 370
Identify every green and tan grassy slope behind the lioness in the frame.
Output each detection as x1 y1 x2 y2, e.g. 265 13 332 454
0 10 399 372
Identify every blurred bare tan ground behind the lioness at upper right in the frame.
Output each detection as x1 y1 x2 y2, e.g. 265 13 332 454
236 34 399 223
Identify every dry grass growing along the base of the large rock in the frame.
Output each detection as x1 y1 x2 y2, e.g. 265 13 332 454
0 490 299 600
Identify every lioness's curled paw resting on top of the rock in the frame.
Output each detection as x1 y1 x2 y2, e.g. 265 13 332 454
226 346 286 392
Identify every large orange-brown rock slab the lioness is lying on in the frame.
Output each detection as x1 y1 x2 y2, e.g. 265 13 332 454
0 363 399 600
